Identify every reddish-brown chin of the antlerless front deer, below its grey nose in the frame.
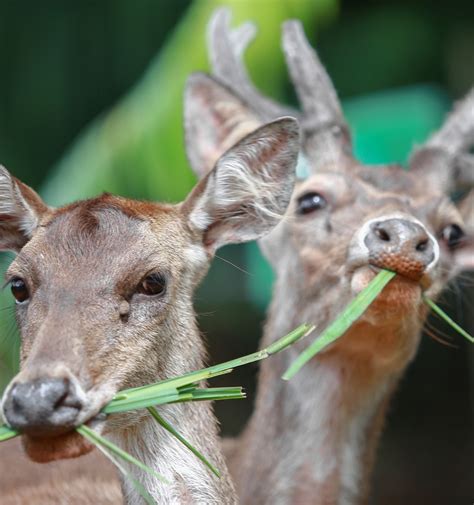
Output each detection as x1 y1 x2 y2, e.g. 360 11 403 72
22 431 94 463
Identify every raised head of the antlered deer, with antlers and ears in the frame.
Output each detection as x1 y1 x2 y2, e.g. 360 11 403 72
186 9 474 366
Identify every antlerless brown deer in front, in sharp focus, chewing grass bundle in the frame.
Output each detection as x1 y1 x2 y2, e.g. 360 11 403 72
0 108 299 505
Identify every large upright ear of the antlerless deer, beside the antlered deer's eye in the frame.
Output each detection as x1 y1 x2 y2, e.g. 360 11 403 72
183 117 300 253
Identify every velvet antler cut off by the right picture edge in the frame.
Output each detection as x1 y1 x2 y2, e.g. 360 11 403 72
410 88 474 192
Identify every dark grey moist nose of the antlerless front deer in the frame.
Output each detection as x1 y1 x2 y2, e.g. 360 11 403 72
3 378 83 437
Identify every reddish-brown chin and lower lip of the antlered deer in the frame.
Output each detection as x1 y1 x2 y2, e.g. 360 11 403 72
351 265 423 314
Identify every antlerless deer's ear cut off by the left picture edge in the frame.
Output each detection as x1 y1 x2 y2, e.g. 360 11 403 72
0 166 48 252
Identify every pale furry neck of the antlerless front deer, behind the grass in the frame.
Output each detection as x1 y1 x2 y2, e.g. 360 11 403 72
110 314 236 505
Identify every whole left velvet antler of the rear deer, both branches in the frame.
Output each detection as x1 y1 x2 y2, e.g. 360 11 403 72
208 8 352 170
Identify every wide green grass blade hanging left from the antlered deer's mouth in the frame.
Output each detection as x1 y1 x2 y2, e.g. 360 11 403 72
283 270 396 380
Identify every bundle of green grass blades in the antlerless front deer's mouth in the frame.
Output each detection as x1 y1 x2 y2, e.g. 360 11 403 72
0 324 314 504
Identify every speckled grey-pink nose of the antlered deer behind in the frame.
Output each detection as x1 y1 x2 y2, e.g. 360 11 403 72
364 218 435 281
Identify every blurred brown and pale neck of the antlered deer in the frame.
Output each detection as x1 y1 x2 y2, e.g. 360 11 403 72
230 274 420 505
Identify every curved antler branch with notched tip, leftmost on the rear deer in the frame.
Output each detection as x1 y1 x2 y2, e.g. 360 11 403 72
207 7 296 121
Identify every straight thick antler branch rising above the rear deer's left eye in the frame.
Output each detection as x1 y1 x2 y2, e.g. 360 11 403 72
282 21 352 162
